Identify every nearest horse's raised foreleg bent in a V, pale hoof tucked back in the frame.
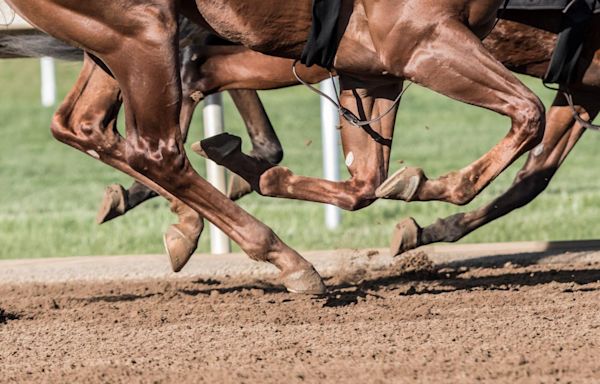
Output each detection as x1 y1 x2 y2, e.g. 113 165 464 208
377 20 544 205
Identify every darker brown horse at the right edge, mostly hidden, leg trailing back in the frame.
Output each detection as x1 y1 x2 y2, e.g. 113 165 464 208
391 11 600 254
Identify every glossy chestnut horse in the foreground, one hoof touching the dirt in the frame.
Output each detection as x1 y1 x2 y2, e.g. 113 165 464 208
9 0 544 292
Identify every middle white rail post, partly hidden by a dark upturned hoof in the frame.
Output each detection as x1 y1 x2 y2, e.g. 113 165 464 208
203 93 231 255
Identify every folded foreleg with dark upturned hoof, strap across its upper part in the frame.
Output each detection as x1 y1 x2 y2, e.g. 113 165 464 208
201 77 401 210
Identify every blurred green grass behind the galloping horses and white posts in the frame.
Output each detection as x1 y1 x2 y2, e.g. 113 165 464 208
0 60 600 258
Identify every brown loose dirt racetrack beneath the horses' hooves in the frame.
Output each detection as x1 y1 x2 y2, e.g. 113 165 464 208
0 244 600 383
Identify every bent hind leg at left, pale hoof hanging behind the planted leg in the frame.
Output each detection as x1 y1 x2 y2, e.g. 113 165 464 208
52 55 204 272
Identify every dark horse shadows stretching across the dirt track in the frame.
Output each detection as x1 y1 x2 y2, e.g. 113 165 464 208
72 267 600 308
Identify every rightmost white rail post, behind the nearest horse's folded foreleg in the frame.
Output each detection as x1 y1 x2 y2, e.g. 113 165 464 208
321 78 342 229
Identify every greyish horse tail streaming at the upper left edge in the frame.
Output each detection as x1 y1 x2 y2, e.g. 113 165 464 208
0 31 83 61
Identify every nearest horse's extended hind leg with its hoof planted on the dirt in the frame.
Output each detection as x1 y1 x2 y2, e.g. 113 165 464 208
91 13 325 293
